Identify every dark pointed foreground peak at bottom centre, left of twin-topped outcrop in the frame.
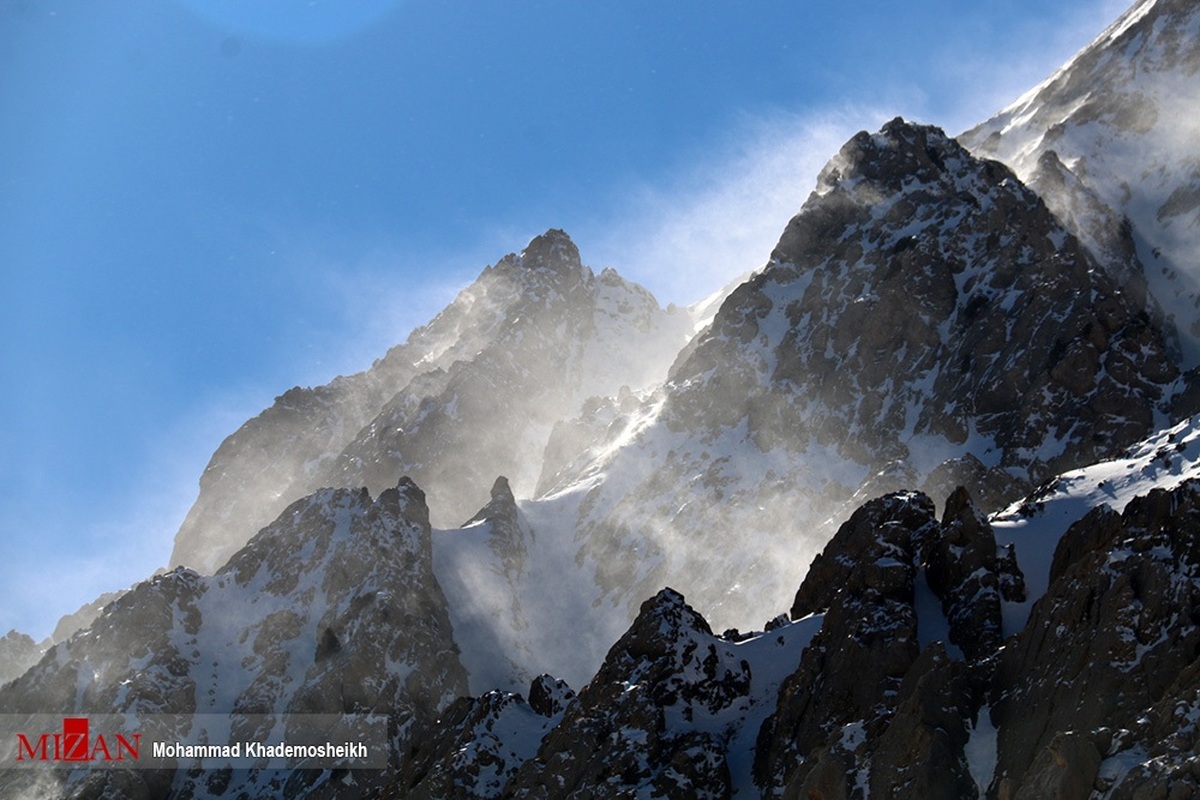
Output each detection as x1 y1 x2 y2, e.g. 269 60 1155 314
504 589 750 798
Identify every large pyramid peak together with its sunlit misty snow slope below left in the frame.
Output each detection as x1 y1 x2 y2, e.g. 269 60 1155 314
499 119 1182 652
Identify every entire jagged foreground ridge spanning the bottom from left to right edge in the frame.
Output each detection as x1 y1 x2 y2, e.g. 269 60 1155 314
7 419 1200 798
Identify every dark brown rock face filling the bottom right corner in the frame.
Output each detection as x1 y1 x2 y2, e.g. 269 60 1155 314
991 481 1200 798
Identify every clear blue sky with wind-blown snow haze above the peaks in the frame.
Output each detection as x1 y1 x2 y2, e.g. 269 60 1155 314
0 0 1124 637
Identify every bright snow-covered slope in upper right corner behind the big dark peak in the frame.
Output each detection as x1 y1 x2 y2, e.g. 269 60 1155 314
961 0 1200 368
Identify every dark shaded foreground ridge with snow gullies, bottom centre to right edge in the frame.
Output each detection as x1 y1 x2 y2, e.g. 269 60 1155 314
388 419 1200 799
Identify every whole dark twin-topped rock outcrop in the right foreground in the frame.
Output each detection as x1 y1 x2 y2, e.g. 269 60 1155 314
755 491 1019 798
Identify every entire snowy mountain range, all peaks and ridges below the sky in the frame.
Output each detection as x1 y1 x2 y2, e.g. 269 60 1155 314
7 0 1200 800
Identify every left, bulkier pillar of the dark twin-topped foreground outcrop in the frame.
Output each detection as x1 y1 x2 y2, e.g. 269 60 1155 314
755 494 937 798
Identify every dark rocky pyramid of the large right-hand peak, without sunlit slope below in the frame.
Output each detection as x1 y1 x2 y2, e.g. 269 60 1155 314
667 119 1176 501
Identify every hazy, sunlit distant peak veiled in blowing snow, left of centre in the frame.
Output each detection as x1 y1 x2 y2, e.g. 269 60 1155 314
172 230 692 572
